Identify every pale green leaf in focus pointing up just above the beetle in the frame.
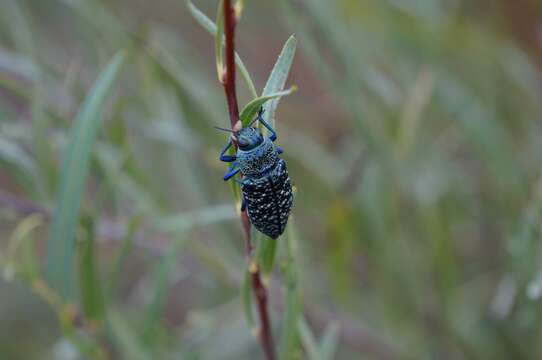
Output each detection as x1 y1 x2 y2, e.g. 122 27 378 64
262 36 297 127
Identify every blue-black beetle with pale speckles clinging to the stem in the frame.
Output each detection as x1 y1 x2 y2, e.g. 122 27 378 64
218 109 293 239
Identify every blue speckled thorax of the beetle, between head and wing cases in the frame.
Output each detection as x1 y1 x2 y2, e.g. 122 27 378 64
237 138 279 178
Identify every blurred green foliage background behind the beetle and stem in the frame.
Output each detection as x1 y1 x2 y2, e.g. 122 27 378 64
0 0 542 360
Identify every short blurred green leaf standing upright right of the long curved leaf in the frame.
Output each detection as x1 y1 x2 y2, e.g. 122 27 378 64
77 216 105 321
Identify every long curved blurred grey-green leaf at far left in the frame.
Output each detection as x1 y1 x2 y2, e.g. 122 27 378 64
46 52 125 300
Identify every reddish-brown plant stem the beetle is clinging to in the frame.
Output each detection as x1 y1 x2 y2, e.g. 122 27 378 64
223 0 275 360
